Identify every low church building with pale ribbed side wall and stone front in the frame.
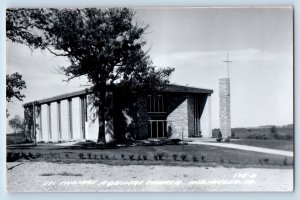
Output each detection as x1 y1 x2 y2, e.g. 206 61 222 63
23 84 213 142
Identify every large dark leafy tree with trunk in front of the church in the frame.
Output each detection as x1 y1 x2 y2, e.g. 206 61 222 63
6 8 173 142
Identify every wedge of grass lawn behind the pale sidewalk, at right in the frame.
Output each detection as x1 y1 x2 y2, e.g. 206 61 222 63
230 139 294 151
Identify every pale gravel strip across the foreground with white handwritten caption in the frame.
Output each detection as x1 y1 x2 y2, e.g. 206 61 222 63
7 162 293 192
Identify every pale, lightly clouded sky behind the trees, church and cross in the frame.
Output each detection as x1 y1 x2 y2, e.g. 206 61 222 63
6 7 293 128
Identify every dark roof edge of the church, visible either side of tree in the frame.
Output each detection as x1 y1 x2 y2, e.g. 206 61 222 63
23 84 213 107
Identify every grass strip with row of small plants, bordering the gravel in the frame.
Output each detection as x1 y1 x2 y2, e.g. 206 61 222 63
7 144 293 168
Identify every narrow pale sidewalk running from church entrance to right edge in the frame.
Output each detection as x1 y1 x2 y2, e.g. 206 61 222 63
189 140 294 157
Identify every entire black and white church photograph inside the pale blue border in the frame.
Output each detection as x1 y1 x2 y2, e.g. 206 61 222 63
6 6 294 192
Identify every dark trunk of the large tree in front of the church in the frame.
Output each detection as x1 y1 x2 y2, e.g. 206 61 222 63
97 90 106 144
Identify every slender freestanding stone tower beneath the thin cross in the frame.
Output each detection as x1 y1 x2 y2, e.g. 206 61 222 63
219 78 231 138
